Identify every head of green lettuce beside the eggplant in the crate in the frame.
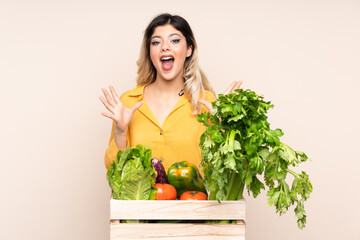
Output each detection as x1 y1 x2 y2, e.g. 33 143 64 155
106 145 156 200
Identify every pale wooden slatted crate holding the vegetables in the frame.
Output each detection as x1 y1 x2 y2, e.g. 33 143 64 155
110 199 246 240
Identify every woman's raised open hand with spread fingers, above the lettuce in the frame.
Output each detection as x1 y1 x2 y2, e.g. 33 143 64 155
100 86 144 135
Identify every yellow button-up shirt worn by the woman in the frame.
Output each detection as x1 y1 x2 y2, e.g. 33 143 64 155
105 86 216 171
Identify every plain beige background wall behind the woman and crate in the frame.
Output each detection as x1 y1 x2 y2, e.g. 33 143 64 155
0 0 360 240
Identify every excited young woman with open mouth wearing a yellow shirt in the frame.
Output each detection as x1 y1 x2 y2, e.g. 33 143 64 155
100 14 241 169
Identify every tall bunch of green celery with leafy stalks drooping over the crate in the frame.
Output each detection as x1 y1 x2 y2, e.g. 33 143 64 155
197 89 313 229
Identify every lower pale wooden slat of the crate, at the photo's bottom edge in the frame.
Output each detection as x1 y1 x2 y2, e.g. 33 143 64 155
110 221 245 240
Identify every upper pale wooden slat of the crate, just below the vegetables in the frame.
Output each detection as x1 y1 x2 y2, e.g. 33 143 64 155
110 199 246 220
